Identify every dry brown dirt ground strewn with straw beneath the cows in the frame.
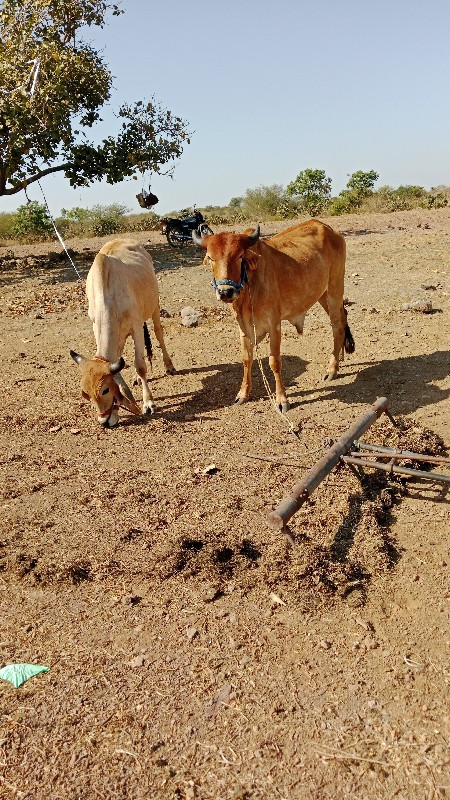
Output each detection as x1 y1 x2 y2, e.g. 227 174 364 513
0 209 450 800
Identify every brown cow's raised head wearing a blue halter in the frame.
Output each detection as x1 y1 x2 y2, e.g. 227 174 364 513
192 225 260 303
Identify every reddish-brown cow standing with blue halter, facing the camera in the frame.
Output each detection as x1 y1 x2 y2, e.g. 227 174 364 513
192 219 355 412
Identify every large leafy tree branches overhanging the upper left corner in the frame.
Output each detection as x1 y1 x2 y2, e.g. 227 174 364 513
0 0 189 196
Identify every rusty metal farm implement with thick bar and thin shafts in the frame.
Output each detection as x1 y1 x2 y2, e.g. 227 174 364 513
269 397 450 535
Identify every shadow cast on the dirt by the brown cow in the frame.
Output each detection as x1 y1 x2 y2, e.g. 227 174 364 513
289 350 450 414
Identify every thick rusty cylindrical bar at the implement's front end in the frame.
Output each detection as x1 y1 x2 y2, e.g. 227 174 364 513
269 397 388 530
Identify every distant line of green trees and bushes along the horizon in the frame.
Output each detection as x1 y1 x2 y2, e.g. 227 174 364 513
0 169 450 242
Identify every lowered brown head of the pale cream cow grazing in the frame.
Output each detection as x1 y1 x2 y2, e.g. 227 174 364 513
70 350 141 428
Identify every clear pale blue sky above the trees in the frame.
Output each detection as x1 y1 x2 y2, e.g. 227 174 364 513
0 0 450 215
